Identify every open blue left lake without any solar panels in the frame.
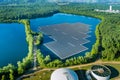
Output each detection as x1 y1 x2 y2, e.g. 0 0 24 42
0 23 28 67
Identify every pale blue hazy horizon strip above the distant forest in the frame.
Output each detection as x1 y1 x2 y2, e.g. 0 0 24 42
0 0 120 4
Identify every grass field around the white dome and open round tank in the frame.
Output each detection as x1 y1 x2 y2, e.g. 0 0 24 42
22 64 120 80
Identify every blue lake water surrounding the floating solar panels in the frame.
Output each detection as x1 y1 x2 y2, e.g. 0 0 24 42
30 13 100 59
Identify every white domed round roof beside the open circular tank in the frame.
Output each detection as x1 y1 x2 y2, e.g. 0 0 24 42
50 68 78 80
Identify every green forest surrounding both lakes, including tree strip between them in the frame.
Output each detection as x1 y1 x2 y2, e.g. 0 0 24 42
0 3 120 80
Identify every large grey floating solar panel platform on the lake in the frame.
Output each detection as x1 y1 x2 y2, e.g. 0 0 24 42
40 23 90 59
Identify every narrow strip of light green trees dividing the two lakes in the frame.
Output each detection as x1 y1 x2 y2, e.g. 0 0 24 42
17 20 33 74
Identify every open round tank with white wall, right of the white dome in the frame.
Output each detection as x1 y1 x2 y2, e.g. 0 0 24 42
86 65 111 80
